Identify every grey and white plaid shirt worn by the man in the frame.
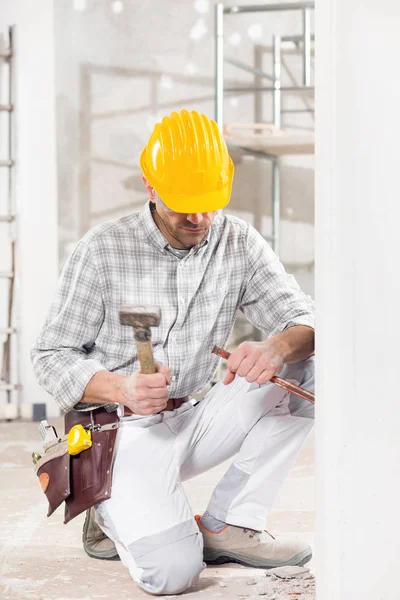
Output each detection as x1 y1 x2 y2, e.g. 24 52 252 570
31 204 314 412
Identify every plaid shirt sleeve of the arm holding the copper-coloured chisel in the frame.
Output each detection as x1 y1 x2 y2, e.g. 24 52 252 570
240 226 315 337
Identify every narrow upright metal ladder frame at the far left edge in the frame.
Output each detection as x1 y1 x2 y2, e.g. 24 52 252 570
0 27 19 418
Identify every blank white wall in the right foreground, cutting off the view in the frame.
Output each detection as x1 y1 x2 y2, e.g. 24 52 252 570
316 0 400 600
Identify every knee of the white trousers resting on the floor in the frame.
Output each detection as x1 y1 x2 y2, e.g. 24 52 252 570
129 533 205 595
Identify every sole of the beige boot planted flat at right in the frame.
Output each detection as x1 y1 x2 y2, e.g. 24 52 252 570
204 548 312 569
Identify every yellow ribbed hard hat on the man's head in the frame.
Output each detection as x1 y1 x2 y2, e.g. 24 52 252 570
140 110 234 213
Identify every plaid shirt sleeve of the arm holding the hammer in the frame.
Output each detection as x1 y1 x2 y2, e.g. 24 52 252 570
31 241 104 412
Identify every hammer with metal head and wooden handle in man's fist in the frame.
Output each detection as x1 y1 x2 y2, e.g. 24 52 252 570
119 304 161 374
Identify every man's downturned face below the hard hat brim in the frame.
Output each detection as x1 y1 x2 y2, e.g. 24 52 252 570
153 194 217 248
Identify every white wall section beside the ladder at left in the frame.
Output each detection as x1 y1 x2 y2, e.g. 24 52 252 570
0 0 58 415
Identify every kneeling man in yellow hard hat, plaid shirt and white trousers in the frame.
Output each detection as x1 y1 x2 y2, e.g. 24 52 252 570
32 110 314 594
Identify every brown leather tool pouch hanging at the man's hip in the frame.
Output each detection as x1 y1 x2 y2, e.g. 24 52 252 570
36 408 119 523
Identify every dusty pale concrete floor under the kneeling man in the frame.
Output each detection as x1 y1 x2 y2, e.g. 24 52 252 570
0 421 314 600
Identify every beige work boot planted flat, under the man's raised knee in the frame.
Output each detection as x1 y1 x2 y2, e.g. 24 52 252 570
195 515 312 569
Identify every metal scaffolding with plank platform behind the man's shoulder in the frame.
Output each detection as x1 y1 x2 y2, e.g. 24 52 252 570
215 1 314 253
